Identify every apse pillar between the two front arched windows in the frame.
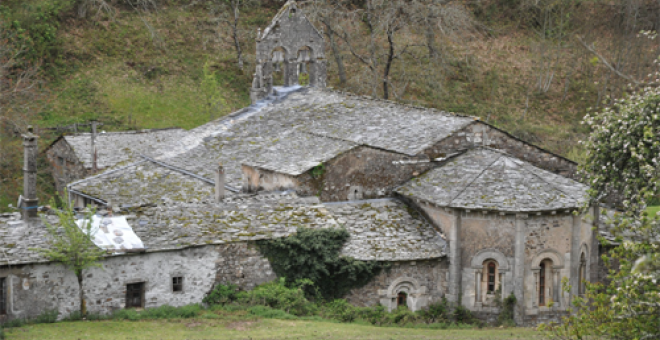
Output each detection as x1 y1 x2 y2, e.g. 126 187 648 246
513 214 527 326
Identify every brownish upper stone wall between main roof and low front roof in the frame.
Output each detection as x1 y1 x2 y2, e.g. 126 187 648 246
298 146 432 202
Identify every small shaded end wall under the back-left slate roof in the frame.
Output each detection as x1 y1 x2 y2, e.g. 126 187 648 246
46 138 90 195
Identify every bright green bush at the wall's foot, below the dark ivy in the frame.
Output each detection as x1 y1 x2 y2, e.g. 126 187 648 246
239 278 316 316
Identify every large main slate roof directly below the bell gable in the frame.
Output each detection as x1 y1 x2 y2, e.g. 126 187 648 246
73 87 473 204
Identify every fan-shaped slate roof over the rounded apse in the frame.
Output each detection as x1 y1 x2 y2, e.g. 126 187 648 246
396 148 587 212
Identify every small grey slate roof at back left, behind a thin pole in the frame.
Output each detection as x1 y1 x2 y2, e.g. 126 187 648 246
63 128 186 169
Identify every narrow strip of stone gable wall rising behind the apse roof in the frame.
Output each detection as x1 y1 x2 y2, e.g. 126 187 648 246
424 121 577 178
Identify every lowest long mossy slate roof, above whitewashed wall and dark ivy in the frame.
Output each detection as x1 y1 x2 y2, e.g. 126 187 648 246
0 197 445 265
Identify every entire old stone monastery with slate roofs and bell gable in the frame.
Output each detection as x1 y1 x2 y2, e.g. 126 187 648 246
0 1 601 325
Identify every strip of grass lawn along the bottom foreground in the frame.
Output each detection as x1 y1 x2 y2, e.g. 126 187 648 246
6 319 543 340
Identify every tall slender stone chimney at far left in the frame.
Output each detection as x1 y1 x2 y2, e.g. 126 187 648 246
21 126 39 220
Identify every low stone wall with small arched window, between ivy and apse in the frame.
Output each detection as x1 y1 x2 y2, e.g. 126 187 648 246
345 258 448 310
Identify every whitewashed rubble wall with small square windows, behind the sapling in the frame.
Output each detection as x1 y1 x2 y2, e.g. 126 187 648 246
0 242 276 322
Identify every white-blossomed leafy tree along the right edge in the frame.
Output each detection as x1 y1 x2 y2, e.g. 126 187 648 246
550 47 660 339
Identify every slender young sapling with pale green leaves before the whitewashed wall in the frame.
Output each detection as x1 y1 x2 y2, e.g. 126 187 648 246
34 200 105 317
